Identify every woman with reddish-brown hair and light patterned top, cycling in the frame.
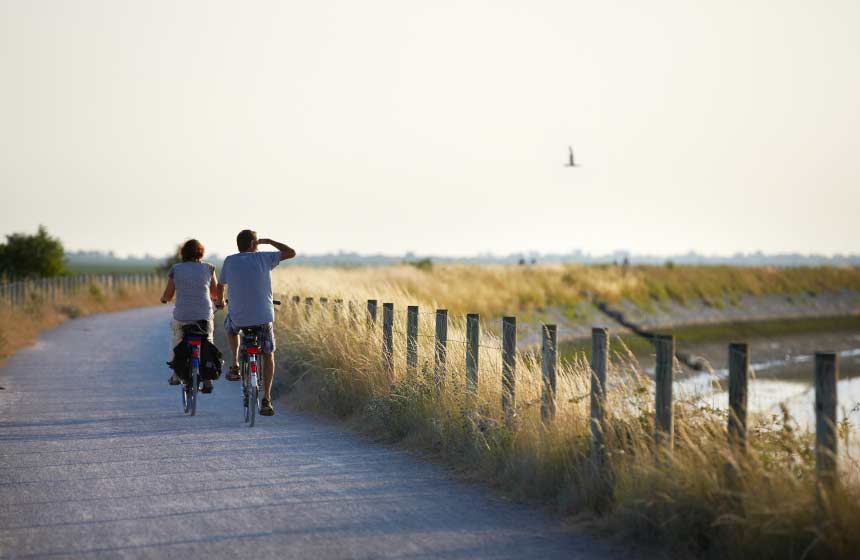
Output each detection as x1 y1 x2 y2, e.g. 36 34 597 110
161 239 218 393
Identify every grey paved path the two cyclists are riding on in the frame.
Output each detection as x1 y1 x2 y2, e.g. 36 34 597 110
0 308 618 560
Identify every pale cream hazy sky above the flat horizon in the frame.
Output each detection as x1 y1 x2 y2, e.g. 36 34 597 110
0 0 860 255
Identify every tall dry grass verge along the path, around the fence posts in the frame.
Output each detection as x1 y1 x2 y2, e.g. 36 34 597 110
278 268 860 558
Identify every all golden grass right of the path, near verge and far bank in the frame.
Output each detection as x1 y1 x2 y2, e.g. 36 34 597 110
278 267 860 558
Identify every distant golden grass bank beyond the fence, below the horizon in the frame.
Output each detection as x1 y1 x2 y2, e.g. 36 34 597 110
274 264 860 317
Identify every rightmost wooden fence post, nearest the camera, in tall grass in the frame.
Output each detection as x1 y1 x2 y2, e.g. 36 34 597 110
815 352 839 516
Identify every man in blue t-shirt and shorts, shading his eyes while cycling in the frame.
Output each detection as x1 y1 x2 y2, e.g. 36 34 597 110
217 229 296 416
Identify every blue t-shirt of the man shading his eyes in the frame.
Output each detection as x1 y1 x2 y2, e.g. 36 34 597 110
219 251 281 327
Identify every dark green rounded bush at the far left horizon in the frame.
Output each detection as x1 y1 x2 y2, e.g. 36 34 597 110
0 226 66 280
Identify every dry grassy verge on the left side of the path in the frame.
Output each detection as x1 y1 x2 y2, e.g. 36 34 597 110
0 281 163 364
